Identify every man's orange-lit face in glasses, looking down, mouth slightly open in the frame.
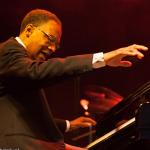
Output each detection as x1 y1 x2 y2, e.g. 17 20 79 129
27 21 62 61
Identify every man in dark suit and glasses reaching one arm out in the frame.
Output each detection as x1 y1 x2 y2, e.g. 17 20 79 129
0 9 147 150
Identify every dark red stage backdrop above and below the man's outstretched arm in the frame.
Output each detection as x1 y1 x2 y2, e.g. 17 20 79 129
0 0 150 119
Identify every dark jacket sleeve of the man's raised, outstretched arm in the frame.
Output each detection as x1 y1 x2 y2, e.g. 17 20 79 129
0 39 93 86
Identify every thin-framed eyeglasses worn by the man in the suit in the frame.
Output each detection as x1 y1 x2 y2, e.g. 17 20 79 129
37 28 60 49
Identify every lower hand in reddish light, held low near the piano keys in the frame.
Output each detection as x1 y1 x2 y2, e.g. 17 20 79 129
70 117 96 130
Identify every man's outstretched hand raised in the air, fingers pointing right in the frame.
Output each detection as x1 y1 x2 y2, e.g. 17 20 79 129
104 44 148 67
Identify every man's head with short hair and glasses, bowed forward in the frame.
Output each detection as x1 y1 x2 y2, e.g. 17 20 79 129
19 9 62 60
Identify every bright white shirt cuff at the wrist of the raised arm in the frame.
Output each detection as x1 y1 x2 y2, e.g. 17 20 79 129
92 52 106 68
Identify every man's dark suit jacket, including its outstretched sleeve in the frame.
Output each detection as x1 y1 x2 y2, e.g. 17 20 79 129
0 38 92 148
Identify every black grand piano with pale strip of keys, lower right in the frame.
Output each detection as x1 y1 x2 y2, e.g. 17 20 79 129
86 82 150 150
